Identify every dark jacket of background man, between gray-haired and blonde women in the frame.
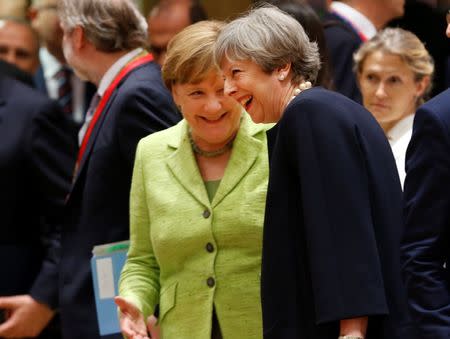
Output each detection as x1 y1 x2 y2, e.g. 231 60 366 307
323 13 362 103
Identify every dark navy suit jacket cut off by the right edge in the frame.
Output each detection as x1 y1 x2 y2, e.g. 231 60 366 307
402 89 450 339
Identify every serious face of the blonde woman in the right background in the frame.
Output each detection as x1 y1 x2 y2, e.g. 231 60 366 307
358 51 428 131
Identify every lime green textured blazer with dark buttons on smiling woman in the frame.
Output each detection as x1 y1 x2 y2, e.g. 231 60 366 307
119 113 271 339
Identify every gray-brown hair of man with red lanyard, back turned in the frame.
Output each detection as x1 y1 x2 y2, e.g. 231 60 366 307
59 0 147 52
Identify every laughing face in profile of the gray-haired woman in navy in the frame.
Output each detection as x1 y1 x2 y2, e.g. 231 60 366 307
221 58 289 123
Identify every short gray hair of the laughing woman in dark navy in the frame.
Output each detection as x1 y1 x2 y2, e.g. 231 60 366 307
215 5 320 84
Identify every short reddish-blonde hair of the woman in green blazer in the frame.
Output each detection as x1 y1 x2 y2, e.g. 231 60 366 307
162 21 225 90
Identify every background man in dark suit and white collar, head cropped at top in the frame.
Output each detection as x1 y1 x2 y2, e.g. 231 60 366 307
324 0 405 103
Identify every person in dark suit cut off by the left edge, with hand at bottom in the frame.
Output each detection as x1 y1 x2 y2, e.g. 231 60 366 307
0 63 76 339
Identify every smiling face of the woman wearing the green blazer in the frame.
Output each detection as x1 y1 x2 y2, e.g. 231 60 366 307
172 70 242 151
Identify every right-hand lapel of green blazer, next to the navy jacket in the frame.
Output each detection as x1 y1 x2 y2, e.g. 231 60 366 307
211 112 266 208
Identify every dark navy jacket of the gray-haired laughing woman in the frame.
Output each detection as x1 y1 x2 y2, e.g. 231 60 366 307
262 88 414 339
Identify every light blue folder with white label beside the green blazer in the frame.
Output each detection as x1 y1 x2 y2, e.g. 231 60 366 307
91 241 129 335
